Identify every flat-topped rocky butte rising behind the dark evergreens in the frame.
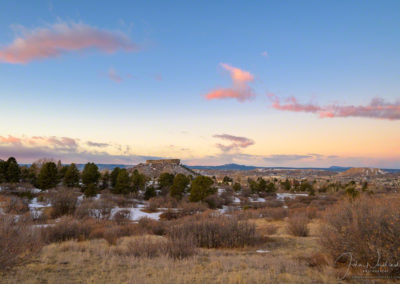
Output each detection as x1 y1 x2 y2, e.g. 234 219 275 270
132 159 197 178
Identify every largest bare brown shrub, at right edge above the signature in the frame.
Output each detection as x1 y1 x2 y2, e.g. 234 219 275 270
320 196 400 272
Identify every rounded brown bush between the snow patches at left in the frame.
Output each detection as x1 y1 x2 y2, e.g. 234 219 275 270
50 190 77 218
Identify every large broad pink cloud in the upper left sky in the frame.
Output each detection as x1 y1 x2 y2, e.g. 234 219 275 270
0 22 138 64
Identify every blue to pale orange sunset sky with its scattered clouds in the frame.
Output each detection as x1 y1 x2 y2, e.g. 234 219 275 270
0 0 400 168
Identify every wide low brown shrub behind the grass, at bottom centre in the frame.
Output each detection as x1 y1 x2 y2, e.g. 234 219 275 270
169 217 258 248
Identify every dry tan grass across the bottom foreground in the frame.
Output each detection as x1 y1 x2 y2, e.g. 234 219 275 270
2 233 336 284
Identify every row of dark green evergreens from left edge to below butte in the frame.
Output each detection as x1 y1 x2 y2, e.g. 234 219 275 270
0 157 217 202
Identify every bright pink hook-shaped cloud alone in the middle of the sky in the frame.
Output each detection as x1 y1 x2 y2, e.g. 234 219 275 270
205 63 255 102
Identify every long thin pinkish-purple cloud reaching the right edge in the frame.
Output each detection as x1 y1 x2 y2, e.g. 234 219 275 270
268 94 400 120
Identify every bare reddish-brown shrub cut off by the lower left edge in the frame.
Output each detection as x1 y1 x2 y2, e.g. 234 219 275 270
0 215 42 270
